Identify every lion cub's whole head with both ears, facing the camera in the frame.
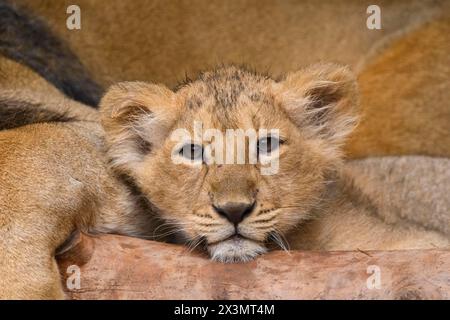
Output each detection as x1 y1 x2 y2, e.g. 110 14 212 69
101 65 356 262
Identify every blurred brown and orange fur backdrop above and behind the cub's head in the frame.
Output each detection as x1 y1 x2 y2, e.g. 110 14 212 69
7 0 450 157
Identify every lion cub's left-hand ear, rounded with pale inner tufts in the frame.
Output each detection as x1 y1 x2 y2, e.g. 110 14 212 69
100 82 176 173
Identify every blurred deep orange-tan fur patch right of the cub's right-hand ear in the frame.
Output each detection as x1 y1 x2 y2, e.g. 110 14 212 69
346 15 450 157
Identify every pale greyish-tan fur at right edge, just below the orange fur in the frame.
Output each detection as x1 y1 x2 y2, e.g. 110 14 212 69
347 156 450 234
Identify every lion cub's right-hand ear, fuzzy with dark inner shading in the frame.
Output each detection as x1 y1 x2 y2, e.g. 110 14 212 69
277 64 358 145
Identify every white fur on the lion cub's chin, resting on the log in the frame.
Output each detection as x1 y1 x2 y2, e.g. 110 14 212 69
208 238 267 263
